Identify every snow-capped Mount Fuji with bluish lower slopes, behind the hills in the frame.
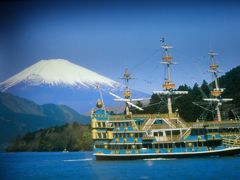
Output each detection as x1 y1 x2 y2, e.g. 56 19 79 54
0 59 146 113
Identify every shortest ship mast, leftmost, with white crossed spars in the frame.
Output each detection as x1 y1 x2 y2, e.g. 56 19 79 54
109 69 144 115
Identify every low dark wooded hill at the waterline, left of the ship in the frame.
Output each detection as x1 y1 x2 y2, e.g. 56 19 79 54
6 122 92 152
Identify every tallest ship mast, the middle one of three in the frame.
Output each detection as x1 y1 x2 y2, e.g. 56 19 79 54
153 38 188 116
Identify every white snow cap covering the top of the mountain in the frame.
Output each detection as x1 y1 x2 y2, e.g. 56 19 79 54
0 59 120 91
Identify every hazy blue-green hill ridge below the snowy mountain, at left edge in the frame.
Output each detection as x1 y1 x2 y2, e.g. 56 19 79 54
0 93 90 149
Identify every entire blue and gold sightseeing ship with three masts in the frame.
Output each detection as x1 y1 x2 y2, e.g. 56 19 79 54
91 42 240 160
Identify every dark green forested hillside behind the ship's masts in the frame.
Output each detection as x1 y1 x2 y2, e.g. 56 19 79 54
131 66 240 121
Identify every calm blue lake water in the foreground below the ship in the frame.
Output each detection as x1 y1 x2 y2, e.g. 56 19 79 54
0 152 240 180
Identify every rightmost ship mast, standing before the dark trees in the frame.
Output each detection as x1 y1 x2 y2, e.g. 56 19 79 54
203 51 233 121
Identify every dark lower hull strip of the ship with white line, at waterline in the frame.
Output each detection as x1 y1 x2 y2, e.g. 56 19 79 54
94 147 240 160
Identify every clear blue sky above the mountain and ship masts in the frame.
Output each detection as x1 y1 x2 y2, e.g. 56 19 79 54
0 1 240 93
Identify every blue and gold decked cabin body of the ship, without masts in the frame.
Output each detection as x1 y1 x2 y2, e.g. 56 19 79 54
91 109 240 154
